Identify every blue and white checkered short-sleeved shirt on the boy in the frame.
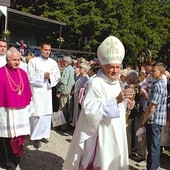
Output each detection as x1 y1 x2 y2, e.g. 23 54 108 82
147 79 167 126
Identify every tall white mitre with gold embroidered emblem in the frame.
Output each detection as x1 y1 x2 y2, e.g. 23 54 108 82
97 36 125 65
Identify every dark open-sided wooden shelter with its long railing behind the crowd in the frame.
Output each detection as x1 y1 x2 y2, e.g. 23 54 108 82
0 0 95 58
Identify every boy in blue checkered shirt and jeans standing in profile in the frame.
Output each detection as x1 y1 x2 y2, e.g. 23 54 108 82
141 63 167 170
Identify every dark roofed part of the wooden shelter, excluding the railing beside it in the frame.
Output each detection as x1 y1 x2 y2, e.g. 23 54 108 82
0 0 66 46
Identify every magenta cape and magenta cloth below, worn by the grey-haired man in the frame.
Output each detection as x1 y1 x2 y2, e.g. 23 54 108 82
0 65 32 157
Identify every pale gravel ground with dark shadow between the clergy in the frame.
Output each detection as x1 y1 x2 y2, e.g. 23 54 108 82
0 130 170 170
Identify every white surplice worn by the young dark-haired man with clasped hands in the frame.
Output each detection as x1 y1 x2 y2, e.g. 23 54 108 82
28 57 61 138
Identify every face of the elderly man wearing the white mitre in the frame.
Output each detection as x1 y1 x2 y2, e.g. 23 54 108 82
102 64 122 80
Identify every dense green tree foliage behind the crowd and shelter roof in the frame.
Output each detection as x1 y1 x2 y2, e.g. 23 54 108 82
11 0 170 64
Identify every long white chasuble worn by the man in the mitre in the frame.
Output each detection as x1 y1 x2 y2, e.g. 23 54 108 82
63 71 129 170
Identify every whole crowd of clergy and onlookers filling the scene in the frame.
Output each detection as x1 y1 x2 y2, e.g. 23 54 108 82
0 36 170 170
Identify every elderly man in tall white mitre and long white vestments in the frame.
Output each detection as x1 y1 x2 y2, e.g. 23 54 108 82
63 36 134 170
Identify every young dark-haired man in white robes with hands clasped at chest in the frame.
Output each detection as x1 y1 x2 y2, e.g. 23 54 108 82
28 43 60 148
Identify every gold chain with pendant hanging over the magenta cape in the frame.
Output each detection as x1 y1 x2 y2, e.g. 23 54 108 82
5 67 24 95
